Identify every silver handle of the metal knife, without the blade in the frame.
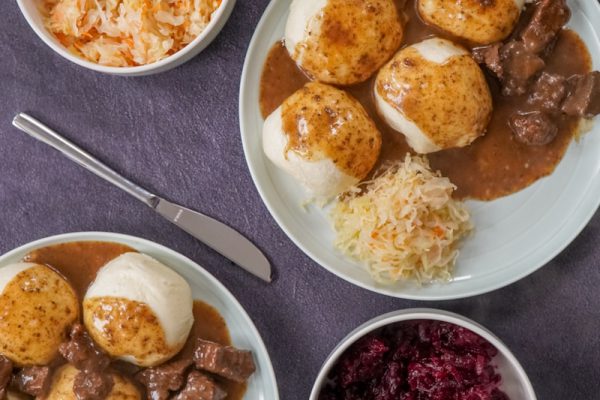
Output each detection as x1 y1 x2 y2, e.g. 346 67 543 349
13 113 158 208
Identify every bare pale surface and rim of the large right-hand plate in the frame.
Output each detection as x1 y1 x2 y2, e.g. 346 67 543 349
240 0 600 300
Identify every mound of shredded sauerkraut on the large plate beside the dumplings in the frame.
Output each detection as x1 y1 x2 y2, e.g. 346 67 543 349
331 155 472 284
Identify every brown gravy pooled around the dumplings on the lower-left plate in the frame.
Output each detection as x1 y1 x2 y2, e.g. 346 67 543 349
24 242 246 400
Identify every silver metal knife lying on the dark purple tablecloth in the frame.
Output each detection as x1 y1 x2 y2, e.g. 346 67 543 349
13 113 271 282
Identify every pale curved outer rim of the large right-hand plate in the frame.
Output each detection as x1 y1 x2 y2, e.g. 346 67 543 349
238 0 600 302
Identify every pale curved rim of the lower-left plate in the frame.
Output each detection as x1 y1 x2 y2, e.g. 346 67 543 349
0 231 280 400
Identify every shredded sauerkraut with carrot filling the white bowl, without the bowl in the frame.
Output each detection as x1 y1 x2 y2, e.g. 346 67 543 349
42 0 221 67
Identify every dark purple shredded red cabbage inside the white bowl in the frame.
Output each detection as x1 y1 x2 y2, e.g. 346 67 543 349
319 321 509 400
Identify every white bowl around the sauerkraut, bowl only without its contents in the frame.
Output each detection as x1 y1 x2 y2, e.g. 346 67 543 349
17 0 235 76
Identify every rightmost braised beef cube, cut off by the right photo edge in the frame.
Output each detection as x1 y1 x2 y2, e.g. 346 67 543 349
562 71 600 118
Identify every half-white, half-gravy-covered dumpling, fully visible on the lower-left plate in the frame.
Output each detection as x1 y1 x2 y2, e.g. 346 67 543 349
83 253 194 367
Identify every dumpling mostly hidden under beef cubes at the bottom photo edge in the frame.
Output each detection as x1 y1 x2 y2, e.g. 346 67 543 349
44 364 141 400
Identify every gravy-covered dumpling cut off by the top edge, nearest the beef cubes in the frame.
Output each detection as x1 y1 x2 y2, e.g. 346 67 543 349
418 0 525 44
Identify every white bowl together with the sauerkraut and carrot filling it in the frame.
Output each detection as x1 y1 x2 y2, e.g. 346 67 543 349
17 0 235 76
